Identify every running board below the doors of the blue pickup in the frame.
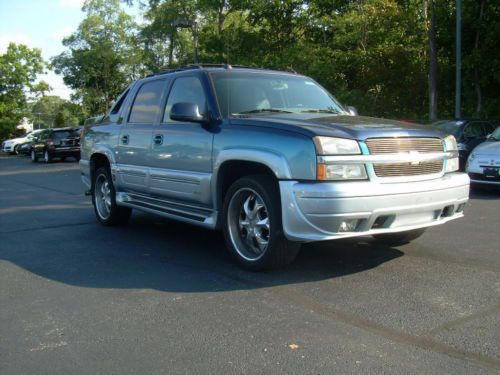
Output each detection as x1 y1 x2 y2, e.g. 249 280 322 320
116 192 217 228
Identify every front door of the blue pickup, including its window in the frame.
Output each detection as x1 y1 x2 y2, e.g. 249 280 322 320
146 75 213 205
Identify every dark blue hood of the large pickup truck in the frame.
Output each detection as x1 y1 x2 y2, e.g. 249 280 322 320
231 113 444 140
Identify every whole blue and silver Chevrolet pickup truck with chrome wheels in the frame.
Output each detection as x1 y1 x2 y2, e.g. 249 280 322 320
80 65 469 270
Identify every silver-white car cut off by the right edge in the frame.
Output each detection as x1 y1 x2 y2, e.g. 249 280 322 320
466 127 500 185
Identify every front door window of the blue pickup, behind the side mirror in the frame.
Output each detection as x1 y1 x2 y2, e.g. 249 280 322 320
163 77 207 122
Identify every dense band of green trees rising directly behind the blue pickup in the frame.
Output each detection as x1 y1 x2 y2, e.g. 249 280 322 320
53 0 500 120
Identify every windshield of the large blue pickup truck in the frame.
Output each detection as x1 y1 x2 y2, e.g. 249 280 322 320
211 72 347 117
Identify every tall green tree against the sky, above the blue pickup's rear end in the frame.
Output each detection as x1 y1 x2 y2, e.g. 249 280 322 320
51 0 144 114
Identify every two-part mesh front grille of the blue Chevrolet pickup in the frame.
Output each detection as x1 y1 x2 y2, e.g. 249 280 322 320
366 137 443 177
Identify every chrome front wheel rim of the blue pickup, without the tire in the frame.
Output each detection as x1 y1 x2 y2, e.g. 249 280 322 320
226 188 270 261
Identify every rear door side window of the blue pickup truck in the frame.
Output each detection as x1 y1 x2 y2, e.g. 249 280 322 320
128 80 165 124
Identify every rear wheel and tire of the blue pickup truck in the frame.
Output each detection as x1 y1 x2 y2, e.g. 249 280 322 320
92 168 132 226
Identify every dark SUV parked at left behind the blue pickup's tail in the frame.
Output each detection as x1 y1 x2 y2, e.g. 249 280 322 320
30 127 81 163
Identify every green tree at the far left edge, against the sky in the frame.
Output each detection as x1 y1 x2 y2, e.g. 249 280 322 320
0 43 49 138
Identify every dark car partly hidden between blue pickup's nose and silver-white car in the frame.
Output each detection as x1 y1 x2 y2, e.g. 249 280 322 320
432 120 496 171
